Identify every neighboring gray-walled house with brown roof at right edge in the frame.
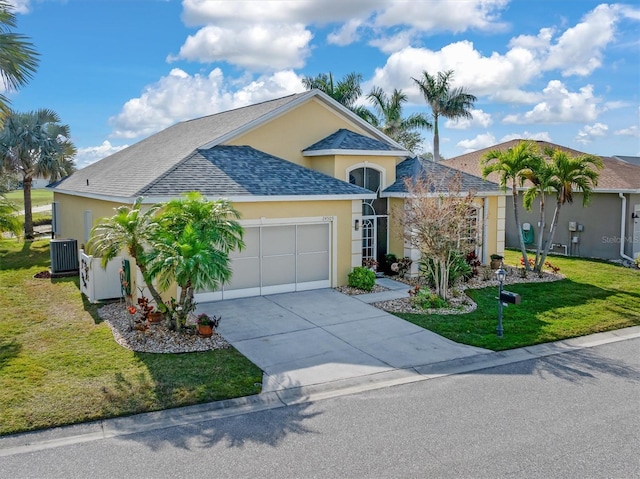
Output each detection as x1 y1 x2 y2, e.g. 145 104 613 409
443 140 640 260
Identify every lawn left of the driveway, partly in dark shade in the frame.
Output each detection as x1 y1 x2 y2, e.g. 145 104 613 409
0 239 262 435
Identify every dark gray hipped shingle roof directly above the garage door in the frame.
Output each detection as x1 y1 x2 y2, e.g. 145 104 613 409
138 145 375 201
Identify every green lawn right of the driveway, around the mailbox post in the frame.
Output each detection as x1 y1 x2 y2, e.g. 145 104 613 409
397 251 640 351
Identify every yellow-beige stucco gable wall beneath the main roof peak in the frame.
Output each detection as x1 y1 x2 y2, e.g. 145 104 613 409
225 98 368 171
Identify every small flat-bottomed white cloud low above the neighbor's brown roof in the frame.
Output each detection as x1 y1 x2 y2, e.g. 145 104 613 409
503 80 600 124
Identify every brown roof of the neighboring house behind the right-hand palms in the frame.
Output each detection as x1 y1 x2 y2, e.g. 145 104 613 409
442 139 640 192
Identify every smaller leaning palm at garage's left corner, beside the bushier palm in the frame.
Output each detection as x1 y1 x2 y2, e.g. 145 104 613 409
86 197 163 306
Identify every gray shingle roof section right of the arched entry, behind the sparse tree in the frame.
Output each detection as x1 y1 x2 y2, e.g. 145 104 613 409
383 157 501 196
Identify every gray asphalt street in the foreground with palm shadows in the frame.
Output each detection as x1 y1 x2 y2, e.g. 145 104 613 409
0 339 640 478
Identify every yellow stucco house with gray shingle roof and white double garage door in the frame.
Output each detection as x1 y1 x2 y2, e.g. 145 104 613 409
52 90 504 301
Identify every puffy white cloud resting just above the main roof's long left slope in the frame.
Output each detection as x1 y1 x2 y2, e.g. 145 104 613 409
109 68 304 138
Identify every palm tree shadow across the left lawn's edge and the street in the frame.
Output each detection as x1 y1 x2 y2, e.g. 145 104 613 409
106 356 321 451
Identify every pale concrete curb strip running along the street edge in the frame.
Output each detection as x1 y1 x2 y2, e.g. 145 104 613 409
0 326 640 457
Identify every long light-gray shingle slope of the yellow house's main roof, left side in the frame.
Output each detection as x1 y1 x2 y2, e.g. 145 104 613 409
55 92 311 198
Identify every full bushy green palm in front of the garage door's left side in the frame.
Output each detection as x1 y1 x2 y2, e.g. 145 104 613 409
145 192 244 328
